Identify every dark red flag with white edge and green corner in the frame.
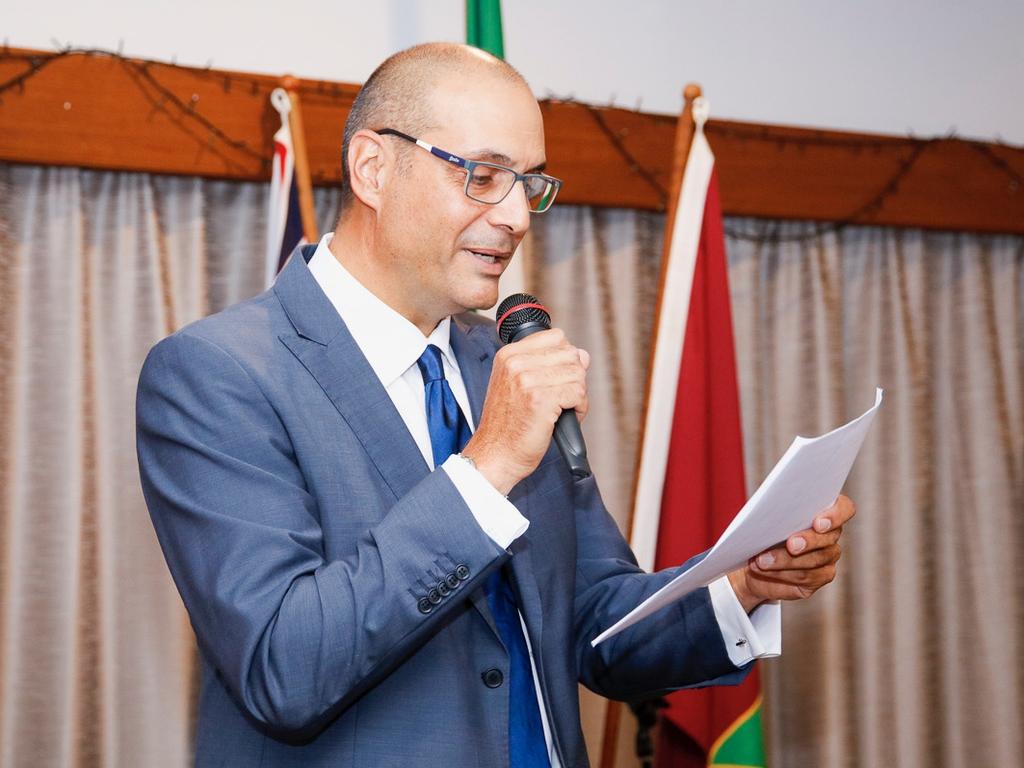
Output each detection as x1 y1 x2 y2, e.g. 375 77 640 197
632 105 764 766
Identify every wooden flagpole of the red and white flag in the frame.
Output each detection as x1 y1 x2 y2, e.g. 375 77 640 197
601 83 701 768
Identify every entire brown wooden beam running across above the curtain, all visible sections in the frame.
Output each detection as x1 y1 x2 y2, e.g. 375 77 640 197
0 48 1024 233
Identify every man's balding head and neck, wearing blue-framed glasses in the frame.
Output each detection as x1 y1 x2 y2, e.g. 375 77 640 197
329 44 547 336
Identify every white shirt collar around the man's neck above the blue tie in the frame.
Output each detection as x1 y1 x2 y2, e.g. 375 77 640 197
309 232 459 388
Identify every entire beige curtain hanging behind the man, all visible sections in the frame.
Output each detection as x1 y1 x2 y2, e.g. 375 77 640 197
0 164 1024 768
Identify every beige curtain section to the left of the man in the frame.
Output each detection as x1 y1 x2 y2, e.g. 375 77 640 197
0 164 336 768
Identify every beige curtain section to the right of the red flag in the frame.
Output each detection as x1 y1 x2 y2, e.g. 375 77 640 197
728 221 1024 768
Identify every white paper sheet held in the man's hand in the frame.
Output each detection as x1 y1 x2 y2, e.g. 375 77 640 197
591 388 882 646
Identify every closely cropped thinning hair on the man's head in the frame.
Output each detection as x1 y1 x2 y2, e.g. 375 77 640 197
339 43 528 214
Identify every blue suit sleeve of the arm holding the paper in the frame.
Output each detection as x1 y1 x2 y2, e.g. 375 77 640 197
574 477 750 700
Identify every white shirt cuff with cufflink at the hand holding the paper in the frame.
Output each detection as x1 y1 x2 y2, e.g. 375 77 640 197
708 577 782 667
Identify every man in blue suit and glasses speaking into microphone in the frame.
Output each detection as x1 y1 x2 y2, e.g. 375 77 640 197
137 45 853 768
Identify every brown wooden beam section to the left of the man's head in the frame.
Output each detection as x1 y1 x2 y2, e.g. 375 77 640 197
0 49 358 184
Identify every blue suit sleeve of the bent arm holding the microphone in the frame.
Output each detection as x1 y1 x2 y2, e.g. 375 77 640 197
136 333 508 737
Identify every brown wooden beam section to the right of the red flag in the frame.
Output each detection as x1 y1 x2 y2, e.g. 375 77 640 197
707 121 1024 233
